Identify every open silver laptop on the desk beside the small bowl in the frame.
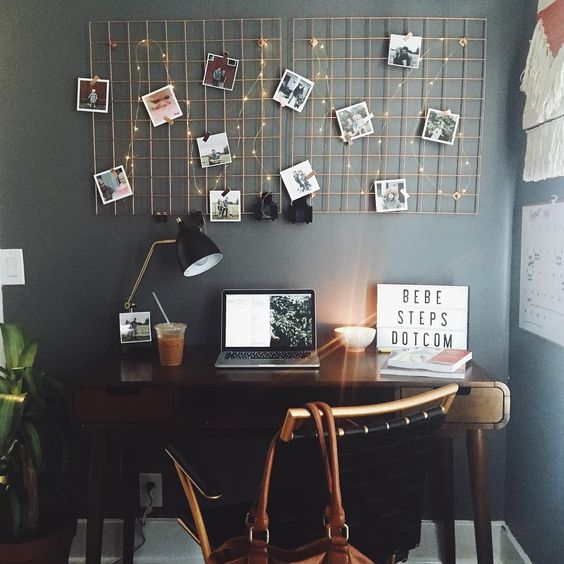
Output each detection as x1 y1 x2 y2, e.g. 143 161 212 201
215 290 319 368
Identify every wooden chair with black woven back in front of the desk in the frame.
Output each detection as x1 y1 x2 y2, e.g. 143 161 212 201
165 384 458 563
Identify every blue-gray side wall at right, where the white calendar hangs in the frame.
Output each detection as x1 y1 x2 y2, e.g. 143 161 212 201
505 2 564 552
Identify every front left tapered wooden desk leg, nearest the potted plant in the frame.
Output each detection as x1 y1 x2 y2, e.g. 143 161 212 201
85 431 107 564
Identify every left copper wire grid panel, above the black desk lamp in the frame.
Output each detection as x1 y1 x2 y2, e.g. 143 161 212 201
90 18 281 215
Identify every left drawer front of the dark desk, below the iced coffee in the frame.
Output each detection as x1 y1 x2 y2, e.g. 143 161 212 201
73 386 174 425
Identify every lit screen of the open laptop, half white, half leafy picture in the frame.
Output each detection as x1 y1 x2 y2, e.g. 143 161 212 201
222 290 316 350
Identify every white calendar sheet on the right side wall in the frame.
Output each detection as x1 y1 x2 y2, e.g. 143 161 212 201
519 202 564 346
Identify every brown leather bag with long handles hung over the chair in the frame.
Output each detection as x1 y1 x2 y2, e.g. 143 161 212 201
206 402 373 564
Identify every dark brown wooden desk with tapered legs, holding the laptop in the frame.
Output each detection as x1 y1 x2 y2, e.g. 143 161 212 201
73 349 510 564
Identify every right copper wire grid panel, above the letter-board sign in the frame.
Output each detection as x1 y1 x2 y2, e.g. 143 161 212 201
292 17 486 214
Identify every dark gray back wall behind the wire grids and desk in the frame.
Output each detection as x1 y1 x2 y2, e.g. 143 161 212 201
0 0 524 518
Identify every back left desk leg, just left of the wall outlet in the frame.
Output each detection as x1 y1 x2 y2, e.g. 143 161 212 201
121 435 139 564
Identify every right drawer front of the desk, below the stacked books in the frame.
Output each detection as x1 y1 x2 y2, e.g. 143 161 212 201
400 386 508 425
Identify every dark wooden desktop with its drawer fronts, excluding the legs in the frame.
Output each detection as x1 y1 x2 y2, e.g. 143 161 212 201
73 348 510 429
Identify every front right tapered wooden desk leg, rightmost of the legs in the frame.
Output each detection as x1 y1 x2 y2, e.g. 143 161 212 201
466 429 493 564
